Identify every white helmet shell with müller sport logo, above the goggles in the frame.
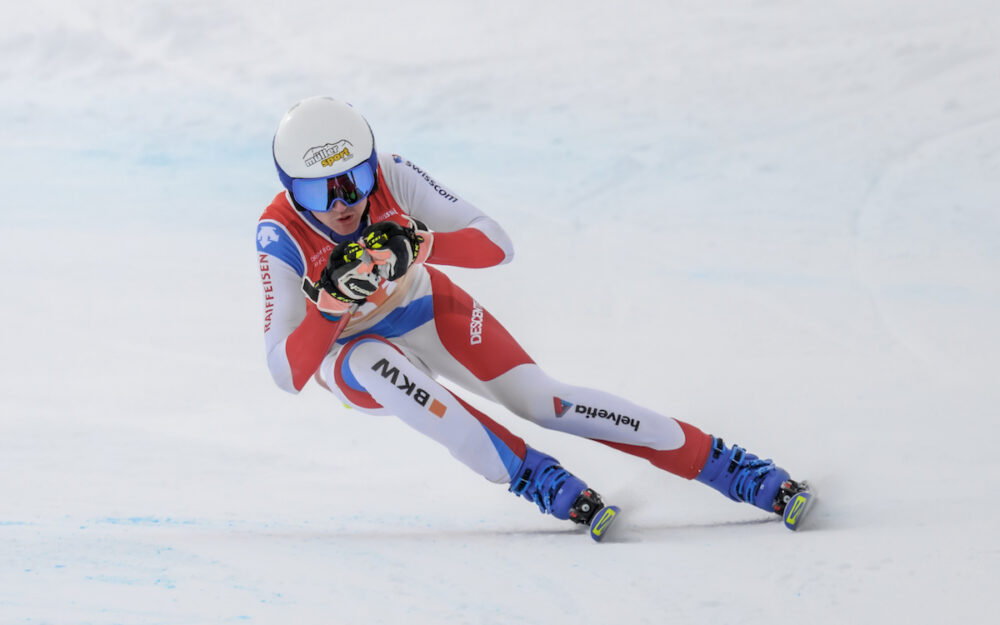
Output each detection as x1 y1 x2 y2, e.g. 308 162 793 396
273 96 375 179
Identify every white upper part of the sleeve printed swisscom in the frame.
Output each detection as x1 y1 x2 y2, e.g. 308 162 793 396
379 154 514 264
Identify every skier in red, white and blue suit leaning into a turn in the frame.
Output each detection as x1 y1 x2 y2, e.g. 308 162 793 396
257 96 808 539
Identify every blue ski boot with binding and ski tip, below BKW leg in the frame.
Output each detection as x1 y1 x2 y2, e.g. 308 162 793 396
510 447 621 541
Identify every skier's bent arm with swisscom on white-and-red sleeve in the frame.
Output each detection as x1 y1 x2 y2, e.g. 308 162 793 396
381 156 514 268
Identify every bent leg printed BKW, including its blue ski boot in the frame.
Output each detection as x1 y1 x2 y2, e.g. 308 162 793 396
324 335 608 523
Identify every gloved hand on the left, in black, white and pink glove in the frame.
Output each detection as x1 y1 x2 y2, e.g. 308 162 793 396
302 241 379 316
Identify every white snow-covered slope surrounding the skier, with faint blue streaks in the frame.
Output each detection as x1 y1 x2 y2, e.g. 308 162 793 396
0 0 1000 624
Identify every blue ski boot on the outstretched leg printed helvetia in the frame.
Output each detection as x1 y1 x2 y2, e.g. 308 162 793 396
694 436 808 515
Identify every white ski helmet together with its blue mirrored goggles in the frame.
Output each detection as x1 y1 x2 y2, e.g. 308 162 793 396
272 96 378 212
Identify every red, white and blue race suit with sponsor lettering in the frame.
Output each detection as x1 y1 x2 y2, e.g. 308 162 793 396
257 155 711 483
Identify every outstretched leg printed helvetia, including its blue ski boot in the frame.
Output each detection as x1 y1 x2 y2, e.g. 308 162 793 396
420 270 800 510
